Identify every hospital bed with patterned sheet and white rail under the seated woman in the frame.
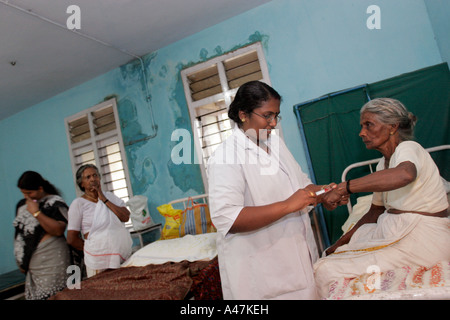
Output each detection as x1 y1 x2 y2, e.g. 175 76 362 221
328 145 450 300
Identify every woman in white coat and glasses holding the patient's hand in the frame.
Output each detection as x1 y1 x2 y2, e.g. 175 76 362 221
207 81 340 299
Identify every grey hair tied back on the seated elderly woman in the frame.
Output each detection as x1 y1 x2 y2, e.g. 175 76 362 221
360 98 417 141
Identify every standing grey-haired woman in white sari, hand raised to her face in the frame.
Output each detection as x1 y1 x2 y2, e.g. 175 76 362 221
67 164 131 277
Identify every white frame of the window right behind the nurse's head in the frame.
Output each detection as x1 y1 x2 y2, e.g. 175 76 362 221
181 42 274 190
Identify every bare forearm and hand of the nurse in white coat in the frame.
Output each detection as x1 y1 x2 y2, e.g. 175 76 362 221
229 185 320 233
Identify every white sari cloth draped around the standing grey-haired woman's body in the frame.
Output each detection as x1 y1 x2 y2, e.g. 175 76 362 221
84 201 133 270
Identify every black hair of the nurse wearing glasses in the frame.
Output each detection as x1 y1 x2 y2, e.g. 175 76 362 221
228 81 281 124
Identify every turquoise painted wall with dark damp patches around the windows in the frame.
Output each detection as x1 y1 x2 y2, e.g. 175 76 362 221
0 0 442 273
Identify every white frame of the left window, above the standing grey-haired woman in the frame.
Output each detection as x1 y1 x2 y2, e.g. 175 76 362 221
64 98 133 199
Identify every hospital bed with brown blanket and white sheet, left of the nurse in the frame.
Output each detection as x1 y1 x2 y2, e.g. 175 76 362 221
51 194 222 300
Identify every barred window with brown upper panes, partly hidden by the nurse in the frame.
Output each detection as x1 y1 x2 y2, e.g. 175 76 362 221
181 42 270 188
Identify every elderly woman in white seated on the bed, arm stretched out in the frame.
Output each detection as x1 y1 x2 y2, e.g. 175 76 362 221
314 98 450 297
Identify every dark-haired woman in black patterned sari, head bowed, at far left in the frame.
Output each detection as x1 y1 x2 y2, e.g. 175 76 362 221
14 171 70 300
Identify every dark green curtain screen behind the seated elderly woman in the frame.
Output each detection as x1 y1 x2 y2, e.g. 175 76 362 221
294 63 450 243
